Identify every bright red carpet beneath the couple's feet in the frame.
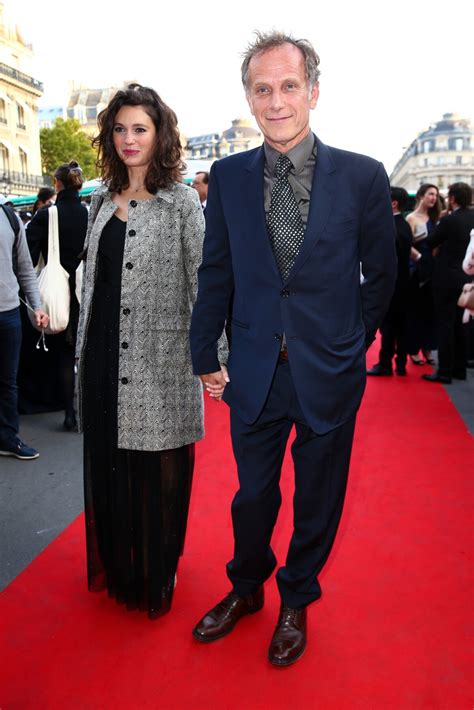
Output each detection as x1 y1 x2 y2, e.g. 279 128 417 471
0 357 474 710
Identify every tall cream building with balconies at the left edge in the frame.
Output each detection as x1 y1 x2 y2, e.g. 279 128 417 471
0 2 43 195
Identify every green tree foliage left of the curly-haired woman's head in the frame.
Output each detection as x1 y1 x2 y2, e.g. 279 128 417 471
40 118 97 180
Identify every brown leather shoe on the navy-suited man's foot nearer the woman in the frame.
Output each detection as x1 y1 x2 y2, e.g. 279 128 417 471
193 586 264 643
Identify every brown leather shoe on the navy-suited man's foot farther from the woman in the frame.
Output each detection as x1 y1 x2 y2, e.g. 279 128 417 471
268 605 306 666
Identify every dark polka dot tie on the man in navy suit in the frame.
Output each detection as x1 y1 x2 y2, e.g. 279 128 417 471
267 155 304 281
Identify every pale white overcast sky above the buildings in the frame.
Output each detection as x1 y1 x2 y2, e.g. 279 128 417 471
5 0 474 172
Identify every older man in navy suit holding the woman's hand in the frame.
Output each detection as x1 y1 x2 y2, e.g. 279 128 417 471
191 32 396 666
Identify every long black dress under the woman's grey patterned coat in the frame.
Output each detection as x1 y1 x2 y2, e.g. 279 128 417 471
83 216 194 618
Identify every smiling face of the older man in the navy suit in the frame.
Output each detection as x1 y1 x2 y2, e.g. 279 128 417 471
247 44 319 153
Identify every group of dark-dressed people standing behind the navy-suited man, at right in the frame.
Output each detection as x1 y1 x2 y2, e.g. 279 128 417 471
367 182 474 384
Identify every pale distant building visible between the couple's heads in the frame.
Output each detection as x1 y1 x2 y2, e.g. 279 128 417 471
186 118 262 159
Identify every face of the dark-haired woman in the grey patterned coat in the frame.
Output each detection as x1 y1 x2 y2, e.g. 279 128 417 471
113 106 156 168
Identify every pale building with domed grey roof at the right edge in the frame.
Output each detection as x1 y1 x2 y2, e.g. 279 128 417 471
390 113 474 192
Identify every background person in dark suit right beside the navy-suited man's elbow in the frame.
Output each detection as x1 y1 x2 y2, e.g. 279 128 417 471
367 187 412 376
